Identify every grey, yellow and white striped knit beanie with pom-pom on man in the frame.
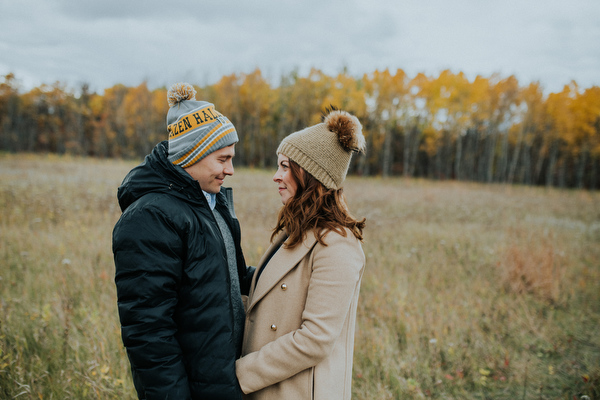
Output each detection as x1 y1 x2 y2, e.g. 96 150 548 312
167 83 239 168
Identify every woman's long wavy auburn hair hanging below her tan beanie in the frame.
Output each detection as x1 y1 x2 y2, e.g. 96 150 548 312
271 160 366 248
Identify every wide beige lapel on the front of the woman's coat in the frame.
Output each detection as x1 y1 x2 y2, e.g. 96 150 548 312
248 231 317 312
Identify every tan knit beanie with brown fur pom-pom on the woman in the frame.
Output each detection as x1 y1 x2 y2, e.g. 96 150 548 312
277 107 365 189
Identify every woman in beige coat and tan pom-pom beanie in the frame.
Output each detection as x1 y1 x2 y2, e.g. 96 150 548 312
236 109 365 400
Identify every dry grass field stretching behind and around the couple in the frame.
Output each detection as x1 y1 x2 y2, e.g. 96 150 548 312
0 154 600 400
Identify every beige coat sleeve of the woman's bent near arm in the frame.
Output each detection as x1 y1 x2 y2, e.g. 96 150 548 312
236 234 364 393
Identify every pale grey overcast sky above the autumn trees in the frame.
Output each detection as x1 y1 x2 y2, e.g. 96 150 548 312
0 0 600 92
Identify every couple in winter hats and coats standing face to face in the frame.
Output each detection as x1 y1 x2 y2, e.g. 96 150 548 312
113 84 365 400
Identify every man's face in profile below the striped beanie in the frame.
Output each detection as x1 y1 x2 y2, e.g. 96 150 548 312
184 144 235 193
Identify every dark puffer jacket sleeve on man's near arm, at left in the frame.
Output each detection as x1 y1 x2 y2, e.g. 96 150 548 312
113 203 190 400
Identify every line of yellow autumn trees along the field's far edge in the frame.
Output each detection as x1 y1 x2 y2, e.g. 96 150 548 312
0 69 600 190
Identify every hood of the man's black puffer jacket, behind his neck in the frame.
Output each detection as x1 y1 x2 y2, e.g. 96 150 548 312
117 140 204 211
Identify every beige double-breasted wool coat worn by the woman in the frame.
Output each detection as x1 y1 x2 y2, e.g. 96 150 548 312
236 230 365 400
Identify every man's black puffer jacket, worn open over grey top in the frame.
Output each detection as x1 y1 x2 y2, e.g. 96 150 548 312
113 142 253 400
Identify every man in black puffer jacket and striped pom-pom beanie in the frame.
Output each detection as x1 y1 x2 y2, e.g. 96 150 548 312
113 84 254 400
